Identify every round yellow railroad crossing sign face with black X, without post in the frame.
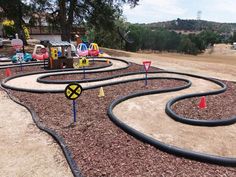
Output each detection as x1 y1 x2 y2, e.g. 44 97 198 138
64 83 83 100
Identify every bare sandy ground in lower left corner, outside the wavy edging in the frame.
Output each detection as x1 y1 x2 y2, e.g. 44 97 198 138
0 91 73 177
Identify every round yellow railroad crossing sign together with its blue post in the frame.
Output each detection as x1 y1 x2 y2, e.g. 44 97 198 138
64 83 83 124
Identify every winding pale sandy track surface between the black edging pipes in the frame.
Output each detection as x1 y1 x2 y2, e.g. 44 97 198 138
2 58 236 169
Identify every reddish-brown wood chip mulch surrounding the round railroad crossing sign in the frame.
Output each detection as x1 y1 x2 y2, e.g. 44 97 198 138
5 66 236 177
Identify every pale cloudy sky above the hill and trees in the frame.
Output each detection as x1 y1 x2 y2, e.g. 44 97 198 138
123 0 236 23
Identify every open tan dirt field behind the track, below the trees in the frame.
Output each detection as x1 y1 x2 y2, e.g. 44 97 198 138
103 44 236 81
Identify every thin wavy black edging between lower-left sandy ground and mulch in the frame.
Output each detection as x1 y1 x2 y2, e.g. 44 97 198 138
0 87 82 177
